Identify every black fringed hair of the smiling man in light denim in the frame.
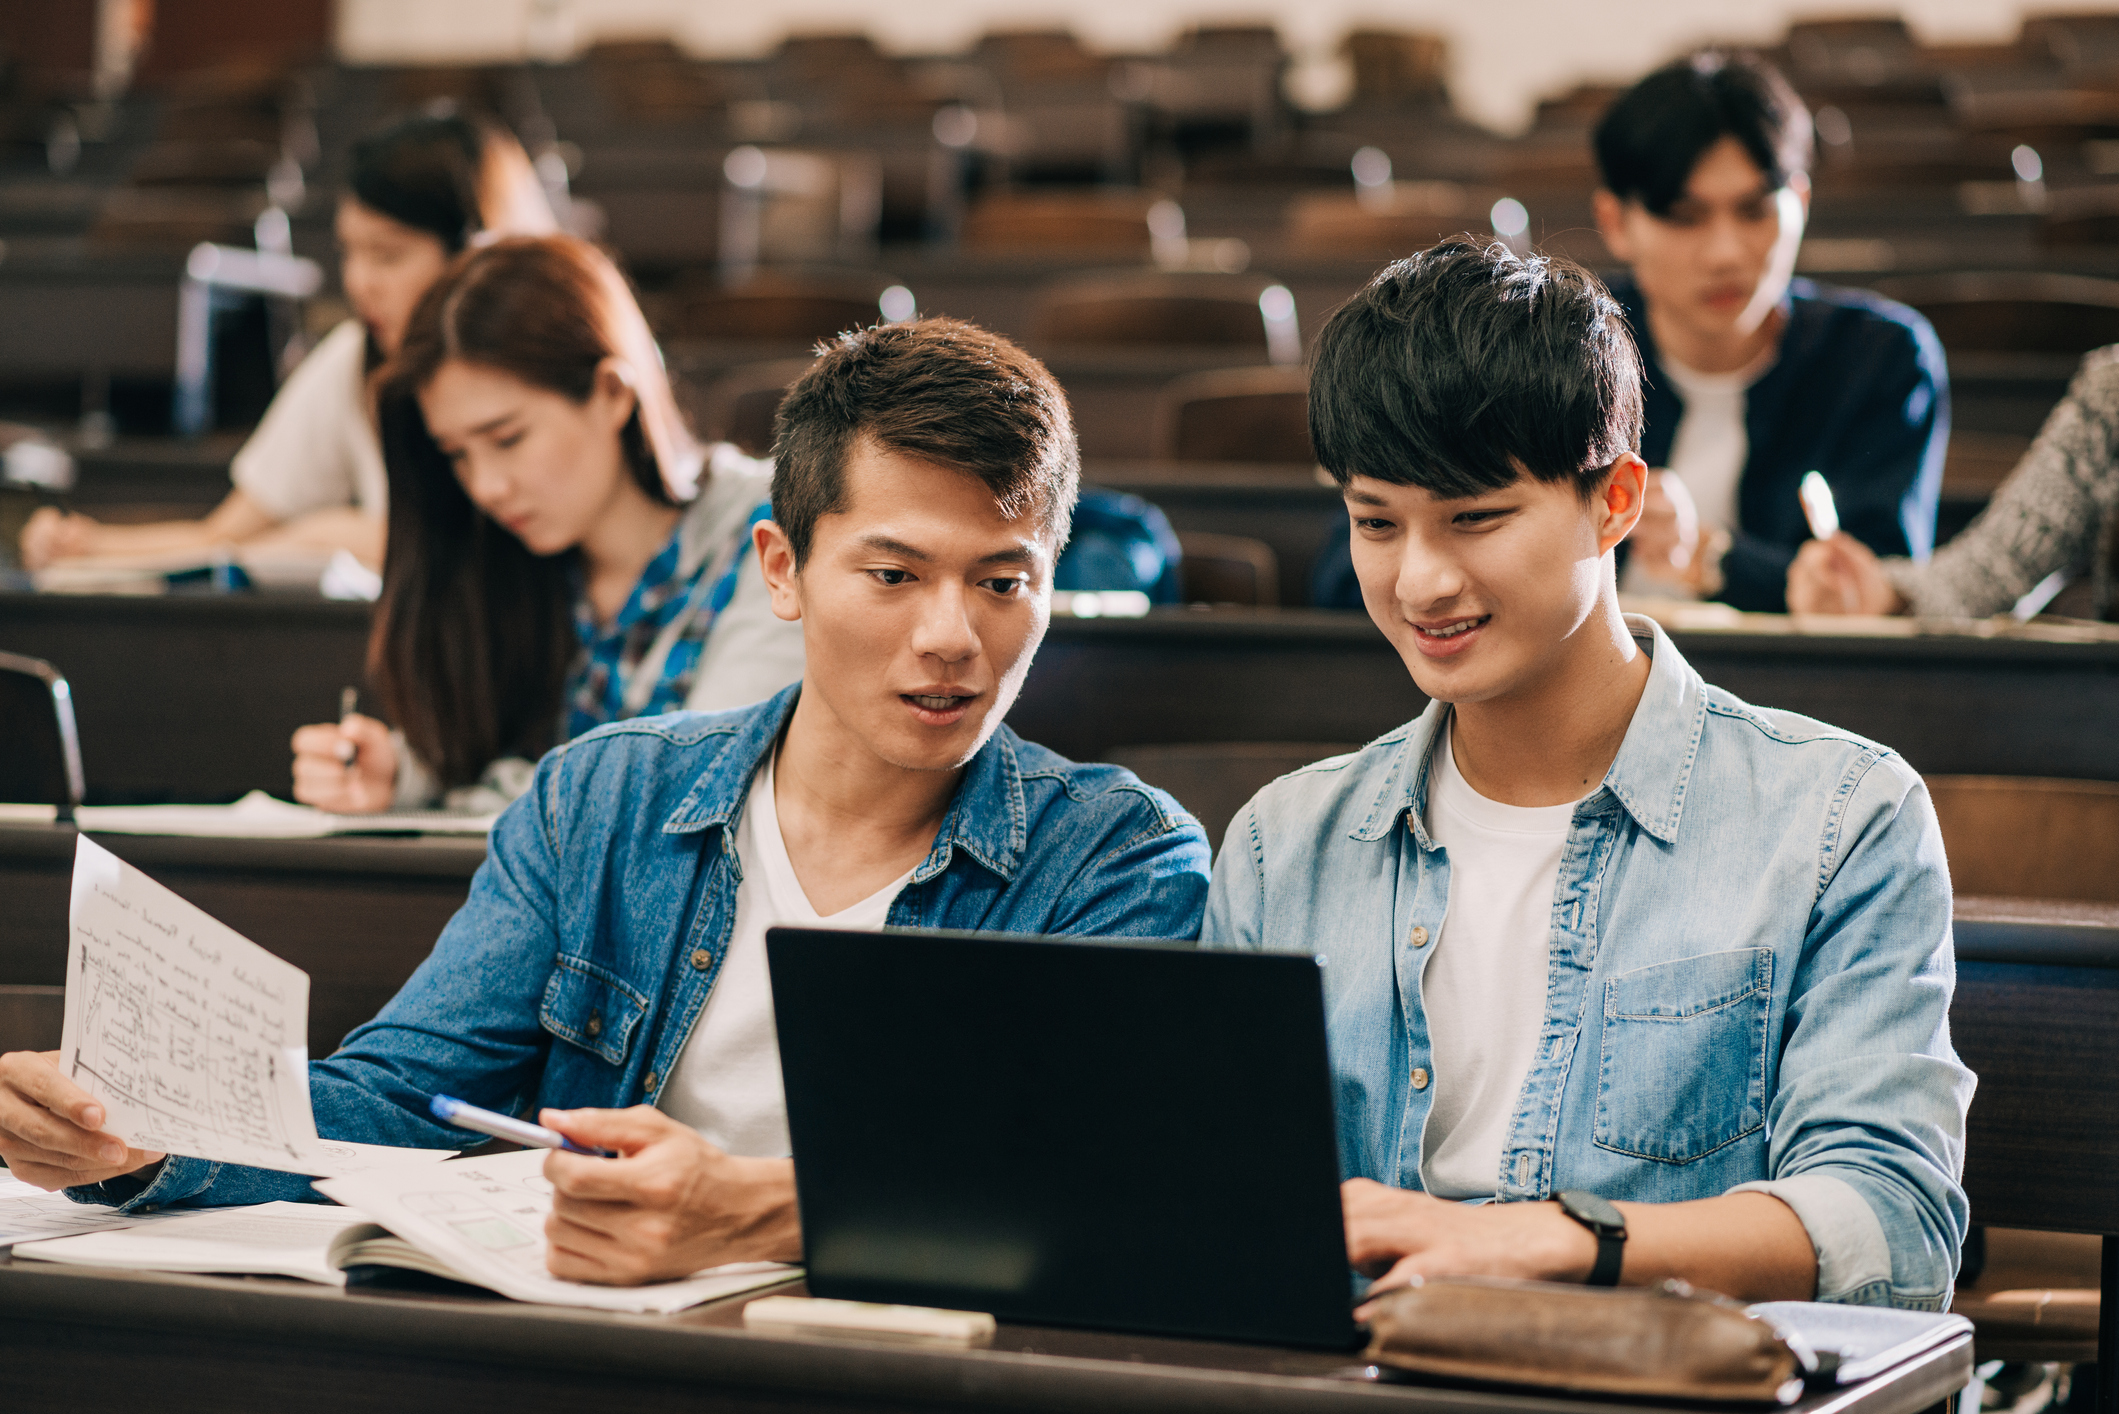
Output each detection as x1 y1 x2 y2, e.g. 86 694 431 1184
1310 240 1640 498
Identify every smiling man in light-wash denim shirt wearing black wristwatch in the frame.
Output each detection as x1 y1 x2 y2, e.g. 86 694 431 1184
1204 244 1973 1310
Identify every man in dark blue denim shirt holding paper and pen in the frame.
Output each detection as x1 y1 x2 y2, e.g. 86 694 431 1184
0 320 1208 1283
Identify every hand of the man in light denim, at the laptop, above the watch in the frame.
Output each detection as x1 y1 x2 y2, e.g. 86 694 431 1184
1339 1179 1596 1316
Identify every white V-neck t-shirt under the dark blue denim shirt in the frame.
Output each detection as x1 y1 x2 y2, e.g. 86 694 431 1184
657 755 913 1157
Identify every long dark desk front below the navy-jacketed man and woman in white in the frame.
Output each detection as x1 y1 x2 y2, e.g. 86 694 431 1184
0 594 2119 801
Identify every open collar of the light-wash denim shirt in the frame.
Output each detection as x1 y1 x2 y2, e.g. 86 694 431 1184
1352 615 1708 850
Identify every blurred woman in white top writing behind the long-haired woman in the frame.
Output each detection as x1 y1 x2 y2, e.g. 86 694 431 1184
21 117 557 570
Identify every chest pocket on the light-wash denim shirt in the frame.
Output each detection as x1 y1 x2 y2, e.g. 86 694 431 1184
1593 948 1774 1164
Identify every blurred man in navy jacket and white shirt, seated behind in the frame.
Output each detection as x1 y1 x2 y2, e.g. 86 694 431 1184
1596 53 1949 611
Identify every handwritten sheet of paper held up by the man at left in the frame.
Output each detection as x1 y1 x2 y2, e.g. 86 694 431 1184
59 835 447 1174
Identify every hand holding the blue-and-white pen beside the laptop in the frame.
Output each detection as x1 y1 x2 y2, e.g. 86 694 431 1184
538 1104 801 1287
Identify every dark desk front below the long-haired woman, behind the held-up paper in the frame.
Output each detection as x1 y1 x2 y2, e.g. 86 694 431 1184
0 825 485 1056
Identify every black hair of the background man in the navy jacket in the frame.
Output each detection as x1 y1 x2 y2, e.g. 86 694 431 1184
1596 49 1812 216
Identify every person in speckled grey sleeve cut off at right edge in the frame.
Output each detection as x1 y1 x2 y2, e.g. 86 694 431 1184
1788 346 2119 619
